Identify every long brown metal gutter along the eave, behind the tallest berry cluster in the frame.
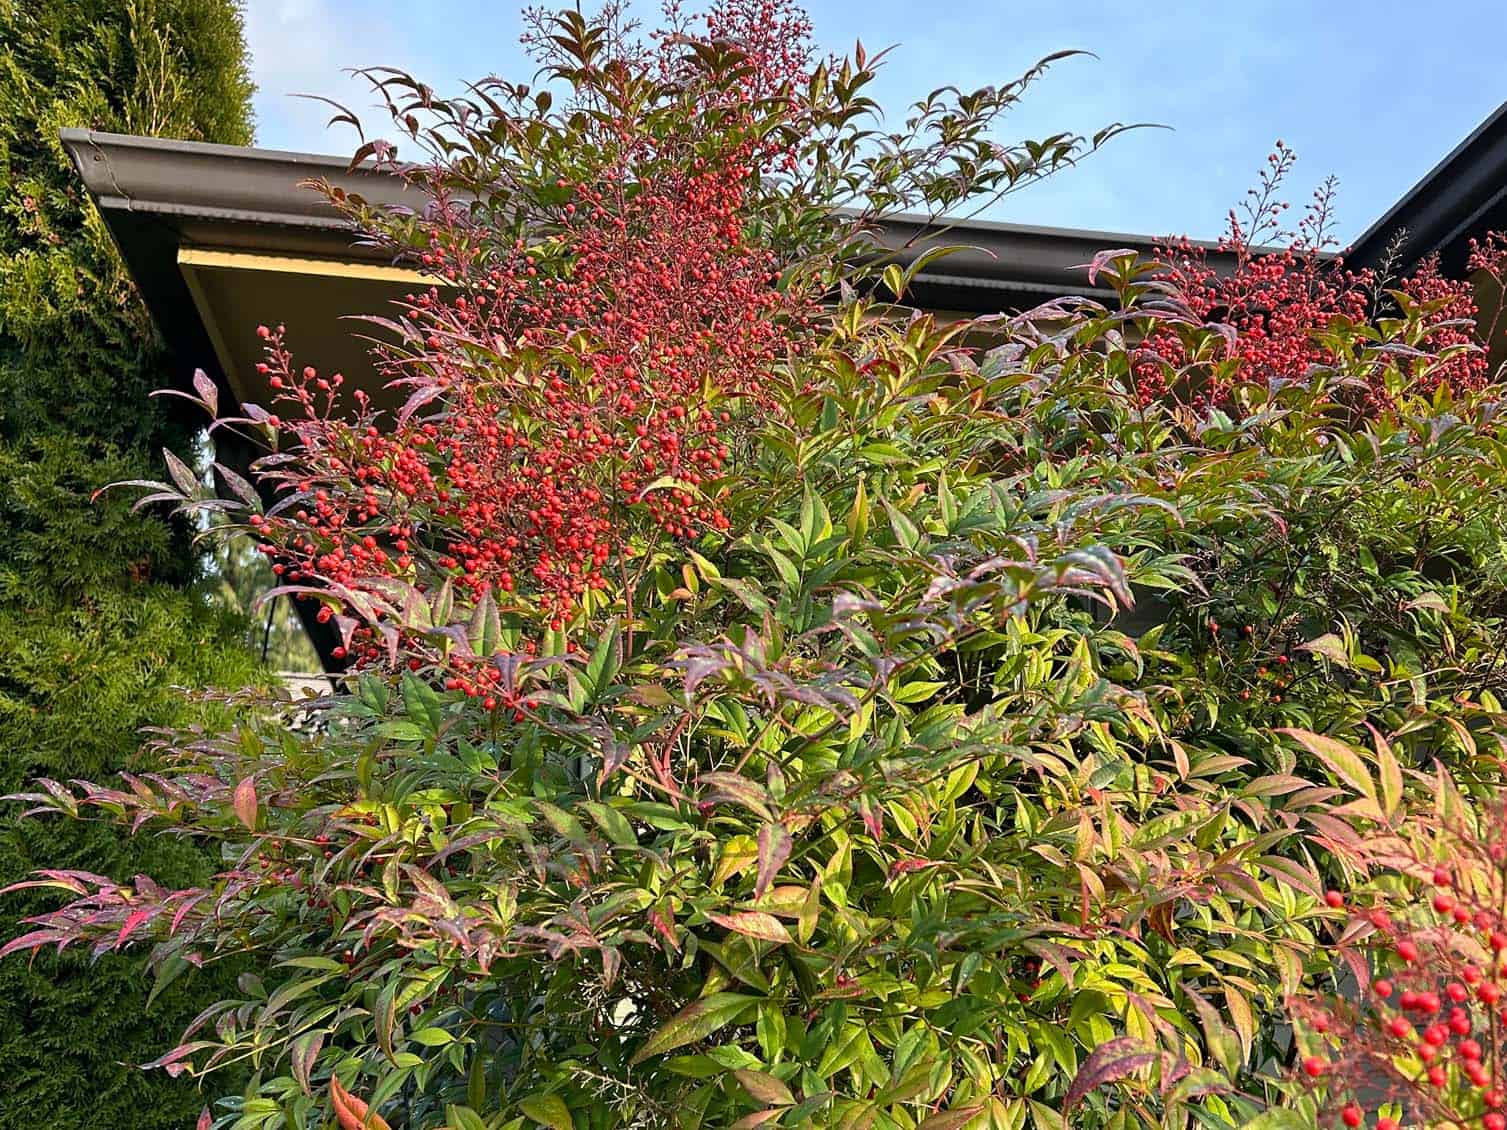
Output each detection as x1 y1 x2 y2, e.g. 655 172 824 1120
62 130 1228 319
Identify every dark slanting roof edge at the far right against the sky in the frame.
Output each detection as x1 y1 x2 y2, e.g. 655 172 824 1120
1346 102 1507 277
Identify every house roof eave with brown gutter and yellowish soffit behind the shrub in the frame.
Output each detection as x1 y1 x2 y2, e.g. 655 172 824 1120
62 130 1227 421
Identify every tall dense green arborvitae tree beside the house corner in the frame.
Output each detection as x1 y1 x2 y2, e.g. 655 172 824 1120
0 0 258 1130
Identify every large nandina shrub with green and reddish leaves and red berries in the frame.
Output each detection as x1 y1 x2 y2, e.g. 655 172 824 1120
6 5 1504 1130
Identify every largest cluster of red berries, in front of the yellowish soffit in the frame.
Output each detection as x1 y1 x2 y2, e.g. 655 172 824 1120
235 8 815 678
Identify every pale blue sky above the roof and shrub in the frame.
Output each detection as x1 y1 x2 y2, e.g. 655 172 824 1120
247 0 1507 240
